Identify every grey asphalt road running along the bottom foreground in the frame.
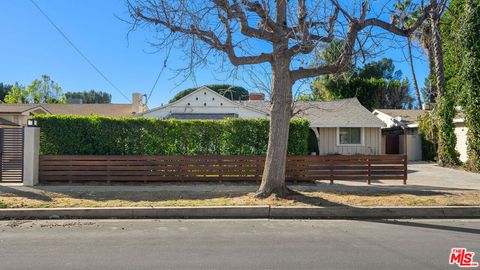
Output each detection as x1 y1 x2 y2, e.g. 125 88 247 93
0 220 480 270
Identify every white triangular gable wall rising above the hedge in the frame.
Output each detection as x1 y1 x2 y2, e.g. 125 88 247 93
144 90 268 119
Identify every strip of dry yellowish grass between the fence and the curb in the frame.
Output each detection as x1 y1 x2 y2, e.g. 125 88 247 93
0 191 480 208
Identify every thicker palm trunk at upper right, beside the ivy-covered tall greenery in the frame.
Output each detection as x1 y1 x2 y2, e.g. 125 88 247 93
430 8 445 97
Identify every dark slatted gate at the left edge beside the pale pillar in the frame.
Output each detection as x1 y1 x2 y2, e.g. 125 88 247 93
0 128 24 183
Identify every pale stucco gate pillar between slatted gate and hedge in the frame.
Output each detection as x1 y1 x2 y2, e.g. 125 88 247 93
23 127 40 186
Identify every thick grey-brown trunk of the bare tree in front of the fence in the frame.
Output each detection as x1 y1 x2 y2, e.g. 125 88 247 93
255 57 292 198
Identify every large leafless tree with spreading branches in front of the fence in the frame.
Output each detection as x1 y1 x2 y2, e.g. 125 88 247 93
128 0 437 197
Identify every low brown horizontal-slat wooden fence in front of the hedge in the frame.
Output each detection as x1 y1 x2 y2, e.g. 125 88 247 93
40 155 407 184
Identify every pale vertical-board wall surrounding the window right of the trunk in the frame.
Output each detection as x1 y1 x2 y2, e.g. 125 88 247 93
319 128 381 155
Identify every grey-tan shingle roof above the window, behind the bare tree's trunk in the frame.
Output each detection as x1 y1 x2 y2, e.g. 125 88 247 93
242 98 385 127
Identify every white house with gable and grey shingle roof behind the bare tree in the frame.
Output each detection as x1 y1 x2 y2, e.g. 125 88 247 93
139 87 385 155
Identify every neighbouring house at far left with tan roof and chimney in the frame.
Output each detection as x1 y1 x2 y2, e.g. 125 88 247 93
0 93 145 127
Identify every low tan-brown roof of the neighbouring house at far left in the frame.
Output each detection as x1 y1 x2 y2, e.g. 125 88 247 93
0 104 133 117
